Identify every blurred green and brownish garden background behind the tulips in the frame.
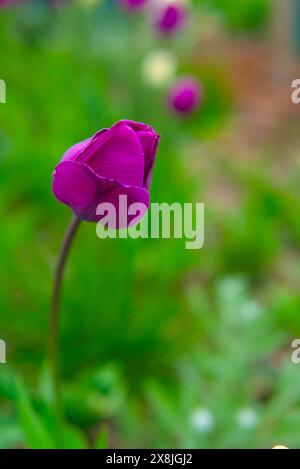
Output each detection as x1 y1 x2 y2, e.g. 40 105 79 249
0 0 300 448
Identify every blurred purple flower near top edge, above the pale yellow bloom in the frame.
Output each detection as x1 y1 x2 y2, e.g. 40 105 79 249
155 4 186 35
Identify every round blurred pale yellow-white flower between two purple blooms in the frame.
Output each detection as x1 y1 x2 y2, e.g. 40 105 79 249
142 49 177 87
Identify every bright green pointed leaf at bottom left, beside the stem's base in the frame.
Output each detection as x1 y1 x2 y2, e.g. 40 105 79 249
16 380 55 449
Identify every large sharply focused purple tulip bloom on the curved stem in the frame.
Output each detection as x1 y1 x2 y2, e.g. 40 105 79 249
53 120 159 228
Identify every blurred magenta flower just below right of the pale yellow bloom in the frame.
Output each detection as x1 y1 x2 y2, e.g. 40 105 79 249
169 77 203 114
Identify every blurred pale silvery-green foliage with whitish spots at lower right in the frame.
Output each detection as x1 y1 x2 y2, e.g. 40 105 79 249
146 278 292 448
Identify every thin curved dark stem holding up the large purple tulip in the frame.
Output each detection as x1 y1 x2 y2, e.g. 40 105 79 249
49 216 80 426
